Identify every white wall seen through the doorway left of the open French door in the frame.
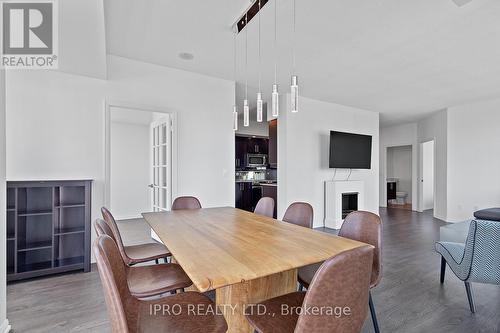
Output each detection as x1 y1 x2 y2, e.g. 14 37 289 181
110 118 151 220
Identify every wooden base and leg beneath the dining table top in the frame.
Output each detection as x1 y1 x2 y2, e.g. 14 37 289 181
215 269 297 333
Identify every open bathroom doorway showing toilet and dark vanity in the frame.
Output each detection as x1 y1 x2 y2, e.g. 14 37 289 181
386 145 414 210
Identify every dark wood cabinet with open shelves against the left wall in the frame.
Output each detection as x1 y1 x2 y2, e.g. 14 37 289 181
6 180 92 281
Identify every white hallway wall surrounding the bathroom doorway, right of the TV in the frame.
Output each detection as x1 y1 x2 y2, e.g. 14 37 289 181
379 123 418 210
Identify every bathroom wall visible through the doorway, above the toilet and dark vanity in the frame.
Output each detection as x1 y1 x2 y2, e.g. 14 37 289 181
387 146 413 203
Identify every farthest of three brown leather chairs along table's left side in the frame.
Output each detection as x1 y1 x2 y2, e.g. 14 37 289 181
100 207 171 265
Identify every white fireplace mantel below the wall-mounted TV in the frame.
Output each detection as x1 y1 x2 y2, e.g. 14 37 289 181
325 180 365 229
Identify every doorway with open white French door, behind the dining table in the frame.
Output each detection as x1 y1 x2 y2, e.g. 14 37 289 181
105 105 175 220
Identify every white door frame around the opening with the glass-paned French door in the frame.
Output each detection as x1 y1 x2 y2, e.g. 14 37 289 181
103 100 178 209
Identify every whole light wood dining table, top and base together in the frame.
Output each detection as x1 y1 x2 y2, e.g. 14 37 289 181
142 207 366 333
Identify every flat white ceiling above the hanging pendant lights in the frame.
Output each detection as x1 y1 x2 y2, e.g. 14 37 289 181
105 0 500 125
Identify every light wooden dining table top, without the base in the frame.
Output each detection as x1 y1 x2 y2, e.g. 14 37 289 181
142 207 366 292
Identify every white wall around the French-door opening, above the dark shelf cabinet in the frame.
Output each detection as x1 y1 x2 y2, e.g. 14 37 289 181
6 56 234 249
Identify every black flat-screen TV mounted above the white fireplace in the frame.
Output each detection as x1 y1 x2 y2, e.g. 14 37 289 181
330 131 372 169
